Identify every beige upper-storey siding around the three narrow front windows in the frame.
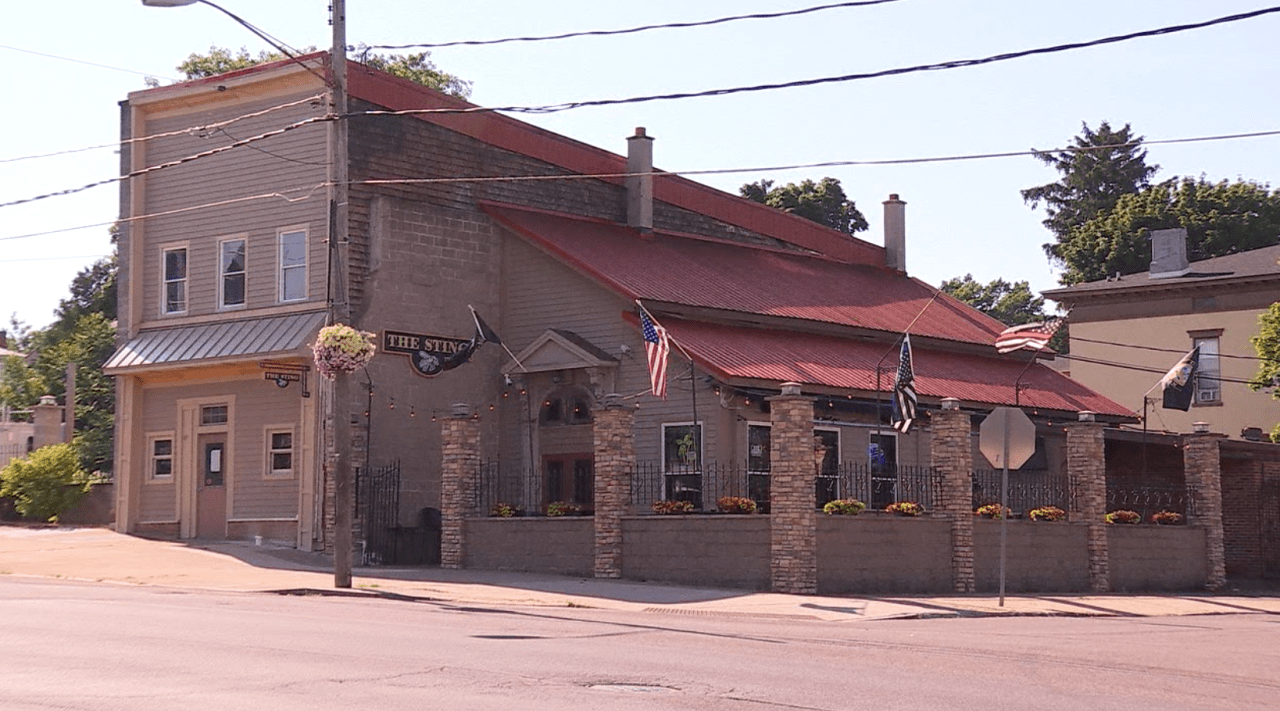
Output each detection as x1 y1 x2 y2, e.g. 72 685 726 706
134 94 328 322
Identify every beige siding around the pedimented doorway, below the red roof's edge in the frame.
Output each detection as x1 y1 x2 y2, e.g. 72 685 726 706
499 236 722 462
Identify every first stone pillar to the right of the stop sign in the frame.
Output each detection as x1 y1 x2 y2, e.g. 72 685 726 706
1066 411 1111 593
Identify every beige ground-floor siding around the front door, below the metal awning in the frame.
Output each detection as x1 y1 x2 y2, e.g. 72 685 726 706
140 378 304 523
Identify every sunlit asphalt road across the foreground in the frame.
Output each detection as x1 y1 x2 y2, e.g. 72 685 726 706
0 576 1280 711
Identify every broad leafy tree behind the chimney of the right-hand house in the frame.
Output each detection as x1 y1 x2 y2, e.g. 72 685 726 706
1056 178 1280 284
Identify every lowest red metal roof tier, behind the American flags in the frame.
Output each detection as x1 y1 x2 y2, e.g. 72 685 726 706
662 318 1134 418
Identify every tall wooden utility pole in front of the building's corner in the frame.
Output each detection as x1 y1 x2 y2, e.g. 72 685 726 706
329 0 355 588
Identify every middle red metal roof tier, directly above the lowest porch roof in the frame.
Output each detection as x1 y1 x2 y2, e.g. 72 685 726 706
485 205 1005 345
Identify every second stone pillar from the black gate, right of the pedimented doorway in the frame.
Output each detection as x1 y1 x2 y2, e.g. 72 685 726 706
591 395 636 578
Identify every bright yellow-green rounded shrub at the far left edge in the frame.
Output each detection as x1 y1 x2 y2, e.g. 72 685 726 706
0 445 90 521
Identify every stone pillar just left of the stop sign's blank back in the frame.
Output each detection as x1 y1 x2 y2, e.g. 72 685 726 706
929 397 977 593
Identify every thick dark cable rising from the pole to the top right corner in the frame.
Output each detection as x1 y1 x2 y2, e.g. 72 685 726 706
352 6 1280 115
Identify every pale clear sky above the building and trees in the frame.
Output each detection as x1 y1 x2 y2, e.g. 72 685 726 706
0 0 1280 327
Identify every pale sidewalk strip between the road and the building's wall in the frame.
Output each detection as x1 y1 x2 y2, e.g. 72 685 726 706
0 527 1280 621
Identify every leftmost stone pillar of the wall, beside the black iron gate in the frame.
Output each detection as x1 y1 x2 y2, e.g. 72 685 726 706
440 404 480 569
